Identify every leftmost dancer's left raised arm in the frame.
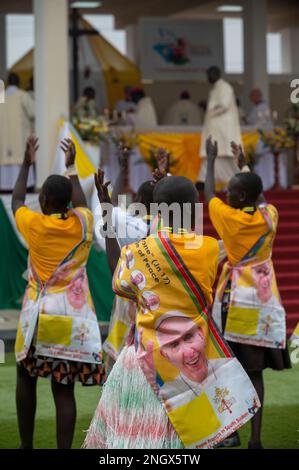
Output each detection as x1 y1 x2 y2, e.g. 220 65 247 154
11 136 38 214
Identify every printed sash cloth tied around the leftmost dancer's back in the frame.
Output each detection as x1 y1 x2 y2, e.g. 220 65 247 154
15 208 102 363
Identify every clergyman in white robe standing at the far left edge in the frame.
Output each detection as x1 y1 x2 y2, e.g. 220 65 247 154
0 73 34 191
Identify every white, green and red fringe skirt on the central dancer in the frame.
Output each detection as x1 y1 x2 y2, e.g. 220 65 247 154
83 346 183 449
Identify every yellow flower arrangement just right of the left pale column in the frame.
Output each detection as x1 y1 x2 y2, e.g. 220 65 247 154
72 116 109 144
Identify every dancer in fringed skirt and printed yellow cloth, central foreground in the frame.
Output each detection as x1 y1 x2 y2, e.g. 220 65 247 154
84 171 259 449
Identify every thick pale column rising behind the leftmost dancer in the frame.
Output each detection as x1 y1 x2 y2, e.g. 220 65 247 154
34 0 69 188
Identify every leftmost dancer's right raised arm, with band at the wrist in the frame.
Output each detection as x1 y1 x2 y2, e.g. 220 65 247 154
60 139 87 207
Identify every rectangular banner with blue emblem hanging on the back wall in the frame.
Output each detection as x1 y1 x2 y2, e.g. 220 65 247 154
138 17 224 81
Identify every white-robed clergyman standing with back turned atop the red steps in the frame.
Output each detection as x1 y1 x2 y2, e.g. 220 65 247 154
198 66 241 188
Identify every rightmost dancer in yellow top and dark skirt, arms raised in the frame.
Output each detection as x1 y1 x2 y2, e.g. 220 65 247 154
205 137 290 449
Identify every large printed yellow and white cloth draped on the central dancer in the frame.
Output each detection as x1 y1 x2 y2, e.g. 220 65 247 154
113 231 260 449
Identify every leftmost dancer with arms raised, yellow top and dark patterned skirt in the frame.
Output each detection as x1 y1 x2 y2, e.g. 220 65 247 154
12 137 103 448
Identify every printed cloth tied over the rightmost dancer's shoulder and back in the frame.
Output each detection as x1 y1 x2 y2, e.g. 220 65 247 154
213 204 286 348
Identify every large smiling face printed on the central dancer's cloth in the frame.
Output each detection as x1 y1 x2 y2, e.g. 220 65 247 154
157 317 208 383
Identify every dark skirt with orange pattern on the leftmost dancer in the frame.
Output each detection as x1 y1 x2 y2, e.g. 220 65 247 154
18 345 104 385
